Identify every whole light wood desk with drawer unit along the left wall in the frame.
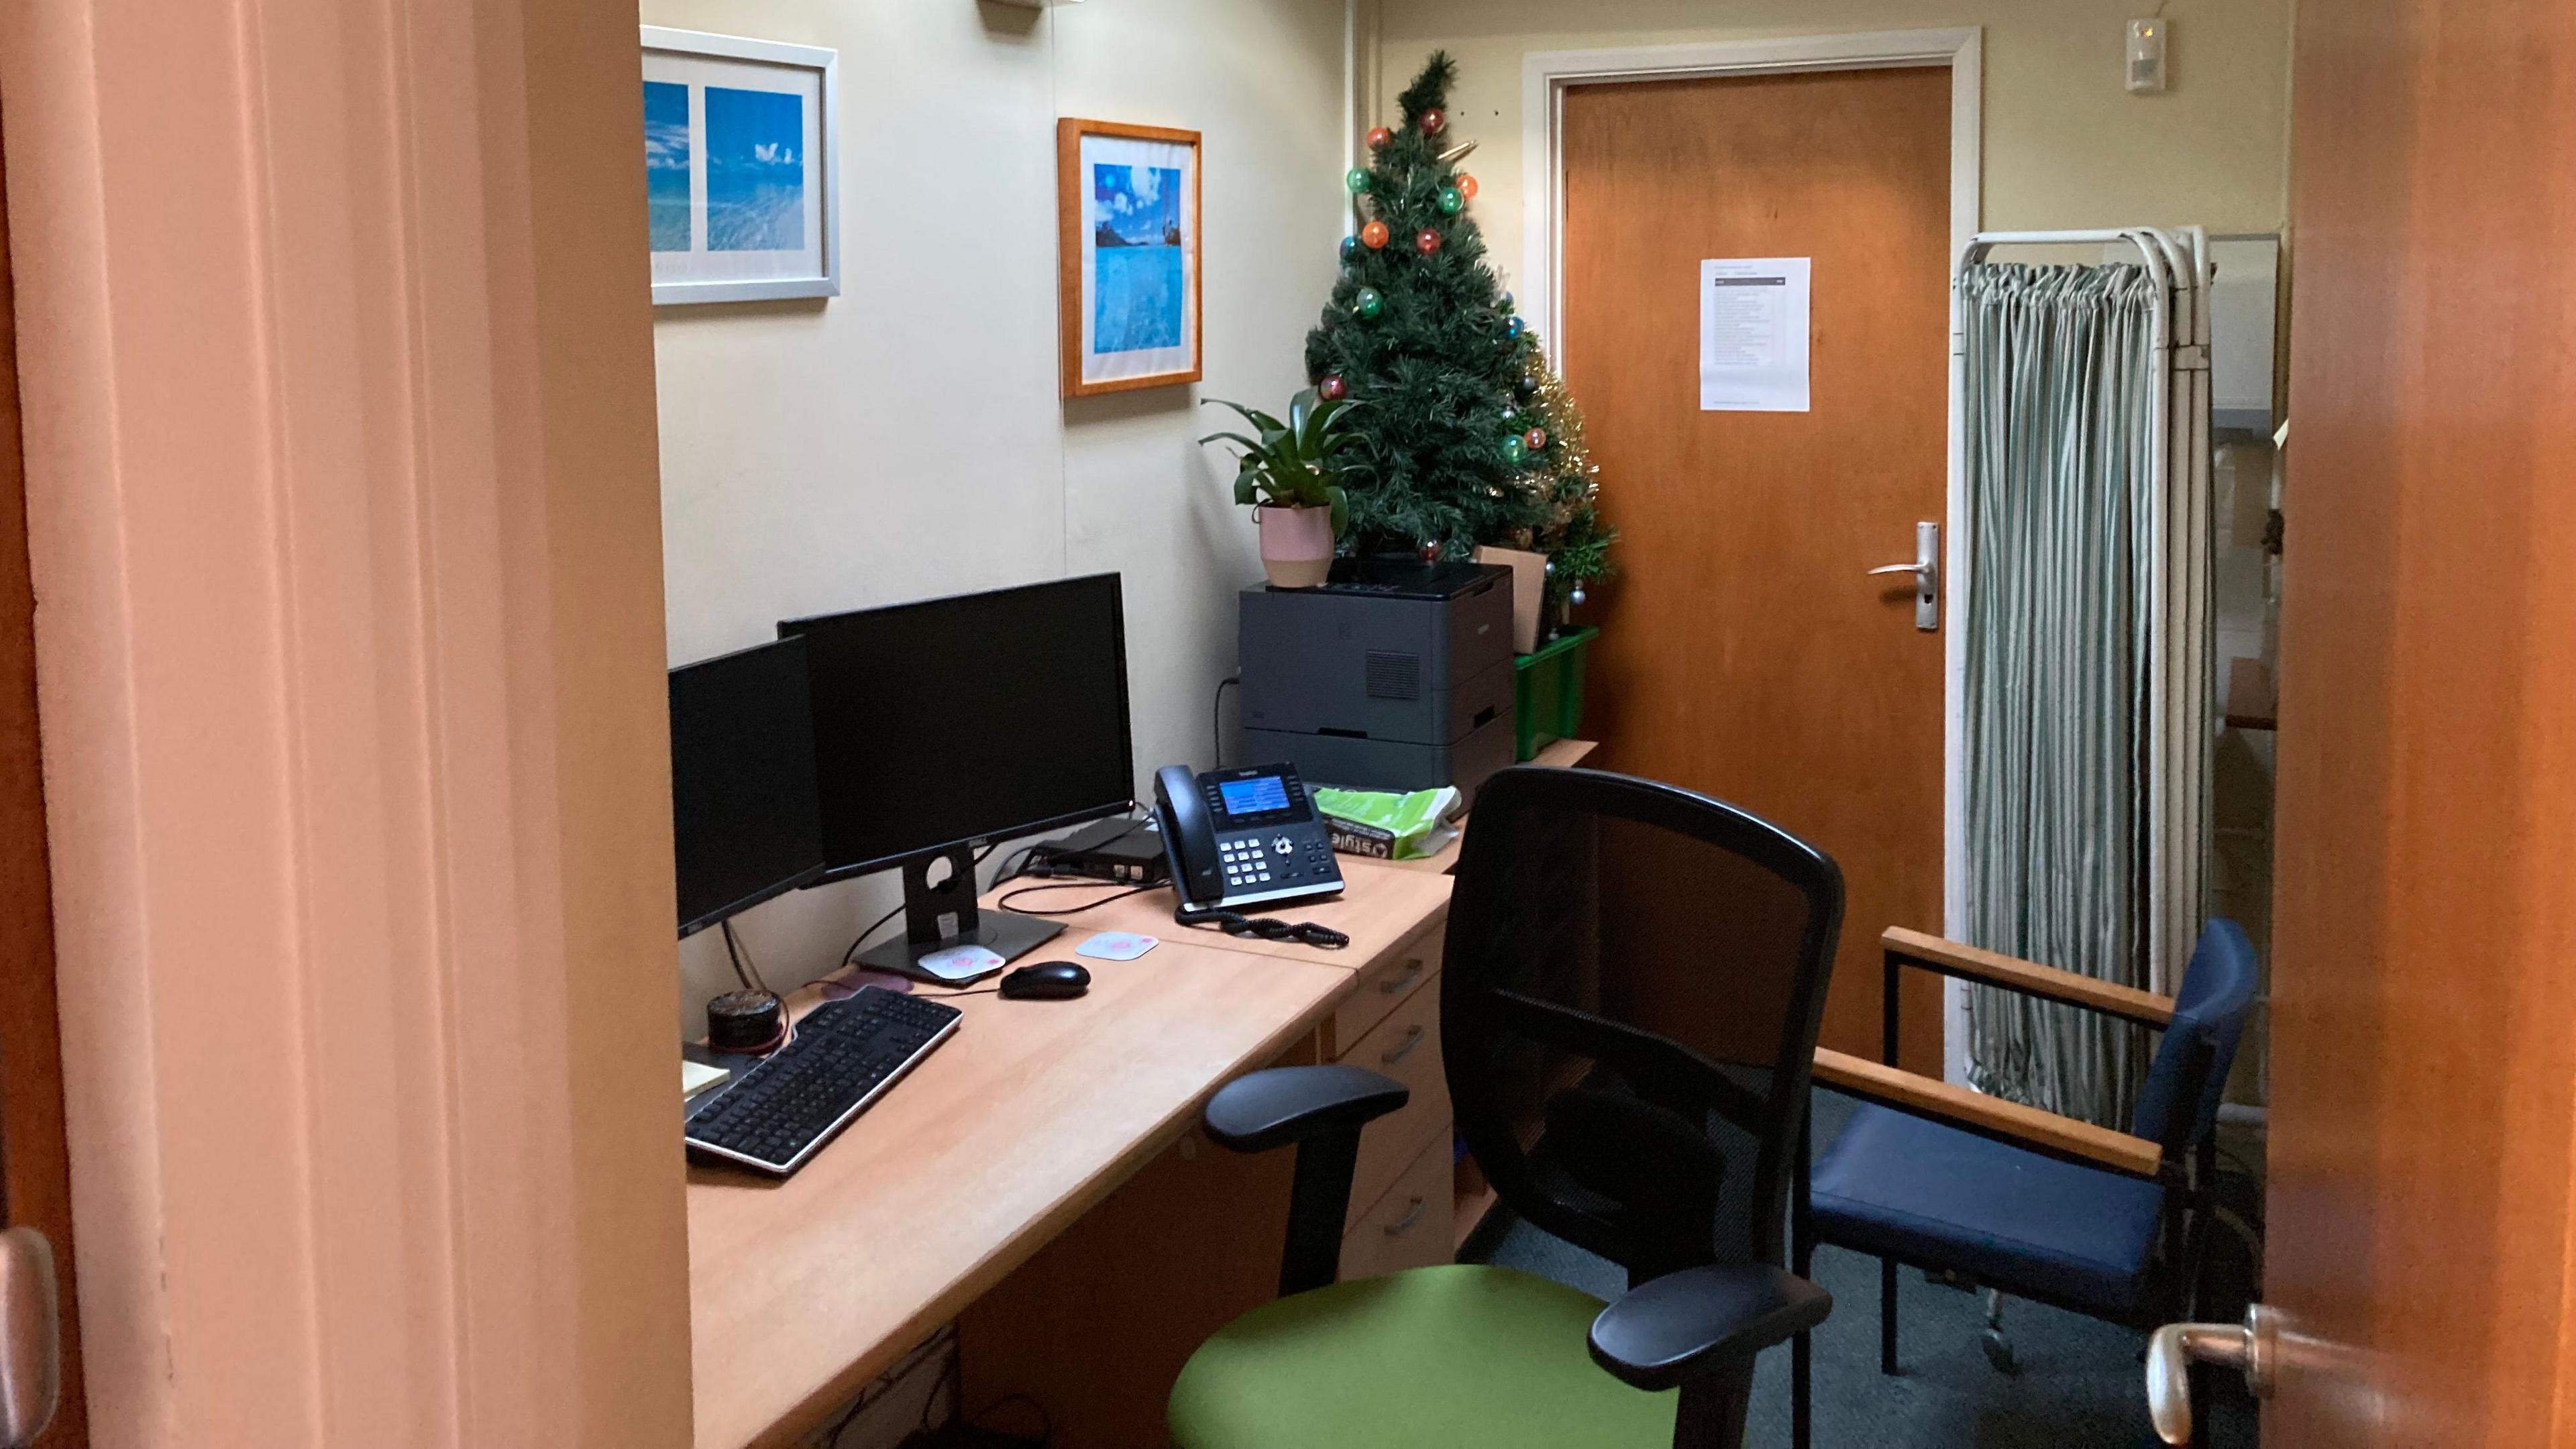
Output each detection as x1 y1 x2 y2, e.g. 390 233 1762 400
688 743 1589 1449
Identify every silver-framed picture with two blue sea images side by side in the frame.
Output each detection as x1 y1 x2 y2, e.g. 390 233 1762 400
644 25 840 305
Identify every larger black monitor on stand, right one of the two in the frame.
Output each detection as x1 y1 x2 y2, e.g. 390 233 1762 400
778 572 1136 969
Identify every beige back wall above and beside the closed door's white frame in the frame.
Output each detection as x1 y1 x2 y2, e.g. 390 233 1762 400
1371 0 2293 290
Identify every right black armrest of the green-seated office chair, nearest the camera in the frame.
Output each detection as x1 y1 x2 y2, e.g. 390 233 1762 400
1592 1263 1834 1390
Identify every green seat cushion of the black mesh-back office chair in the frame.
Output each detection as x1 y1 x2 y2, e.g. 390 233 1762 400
1169 1263 1680 1449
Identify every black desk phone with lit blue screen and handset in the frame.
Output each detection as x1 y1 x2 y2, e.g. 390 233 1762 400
1154 765 1342 910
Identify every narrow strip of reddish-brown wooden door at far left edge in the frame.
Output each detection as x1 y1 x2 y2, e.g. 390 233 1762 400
0 110 90 1449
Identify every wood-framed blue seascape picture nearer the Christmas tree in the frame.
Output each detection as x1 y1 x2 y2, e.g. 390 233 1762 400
1056 119 1200 397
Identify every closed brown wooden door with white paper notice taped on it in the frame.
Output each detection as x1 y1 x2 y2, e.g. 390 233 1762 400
1561 67 1950 1075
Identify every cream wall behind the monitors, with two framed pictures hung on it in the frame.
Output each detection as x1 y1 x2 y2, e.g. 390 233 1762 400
644 0 1342 1026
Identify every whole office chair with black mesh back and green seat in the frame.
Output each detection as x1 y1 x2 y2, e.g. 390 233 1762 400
1167 768 1842 1449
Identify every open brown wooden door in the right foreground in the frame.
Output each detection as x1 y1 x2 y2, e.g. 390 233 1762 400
2264 0 2576 1449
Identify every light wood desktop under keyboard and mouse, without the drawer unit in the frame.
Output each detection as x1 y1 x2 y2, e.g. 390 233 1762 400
688 920 1355 1449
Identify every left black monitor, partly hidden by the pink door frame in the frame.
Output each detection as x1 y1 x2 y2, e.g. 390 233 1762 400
669 639 824 936
